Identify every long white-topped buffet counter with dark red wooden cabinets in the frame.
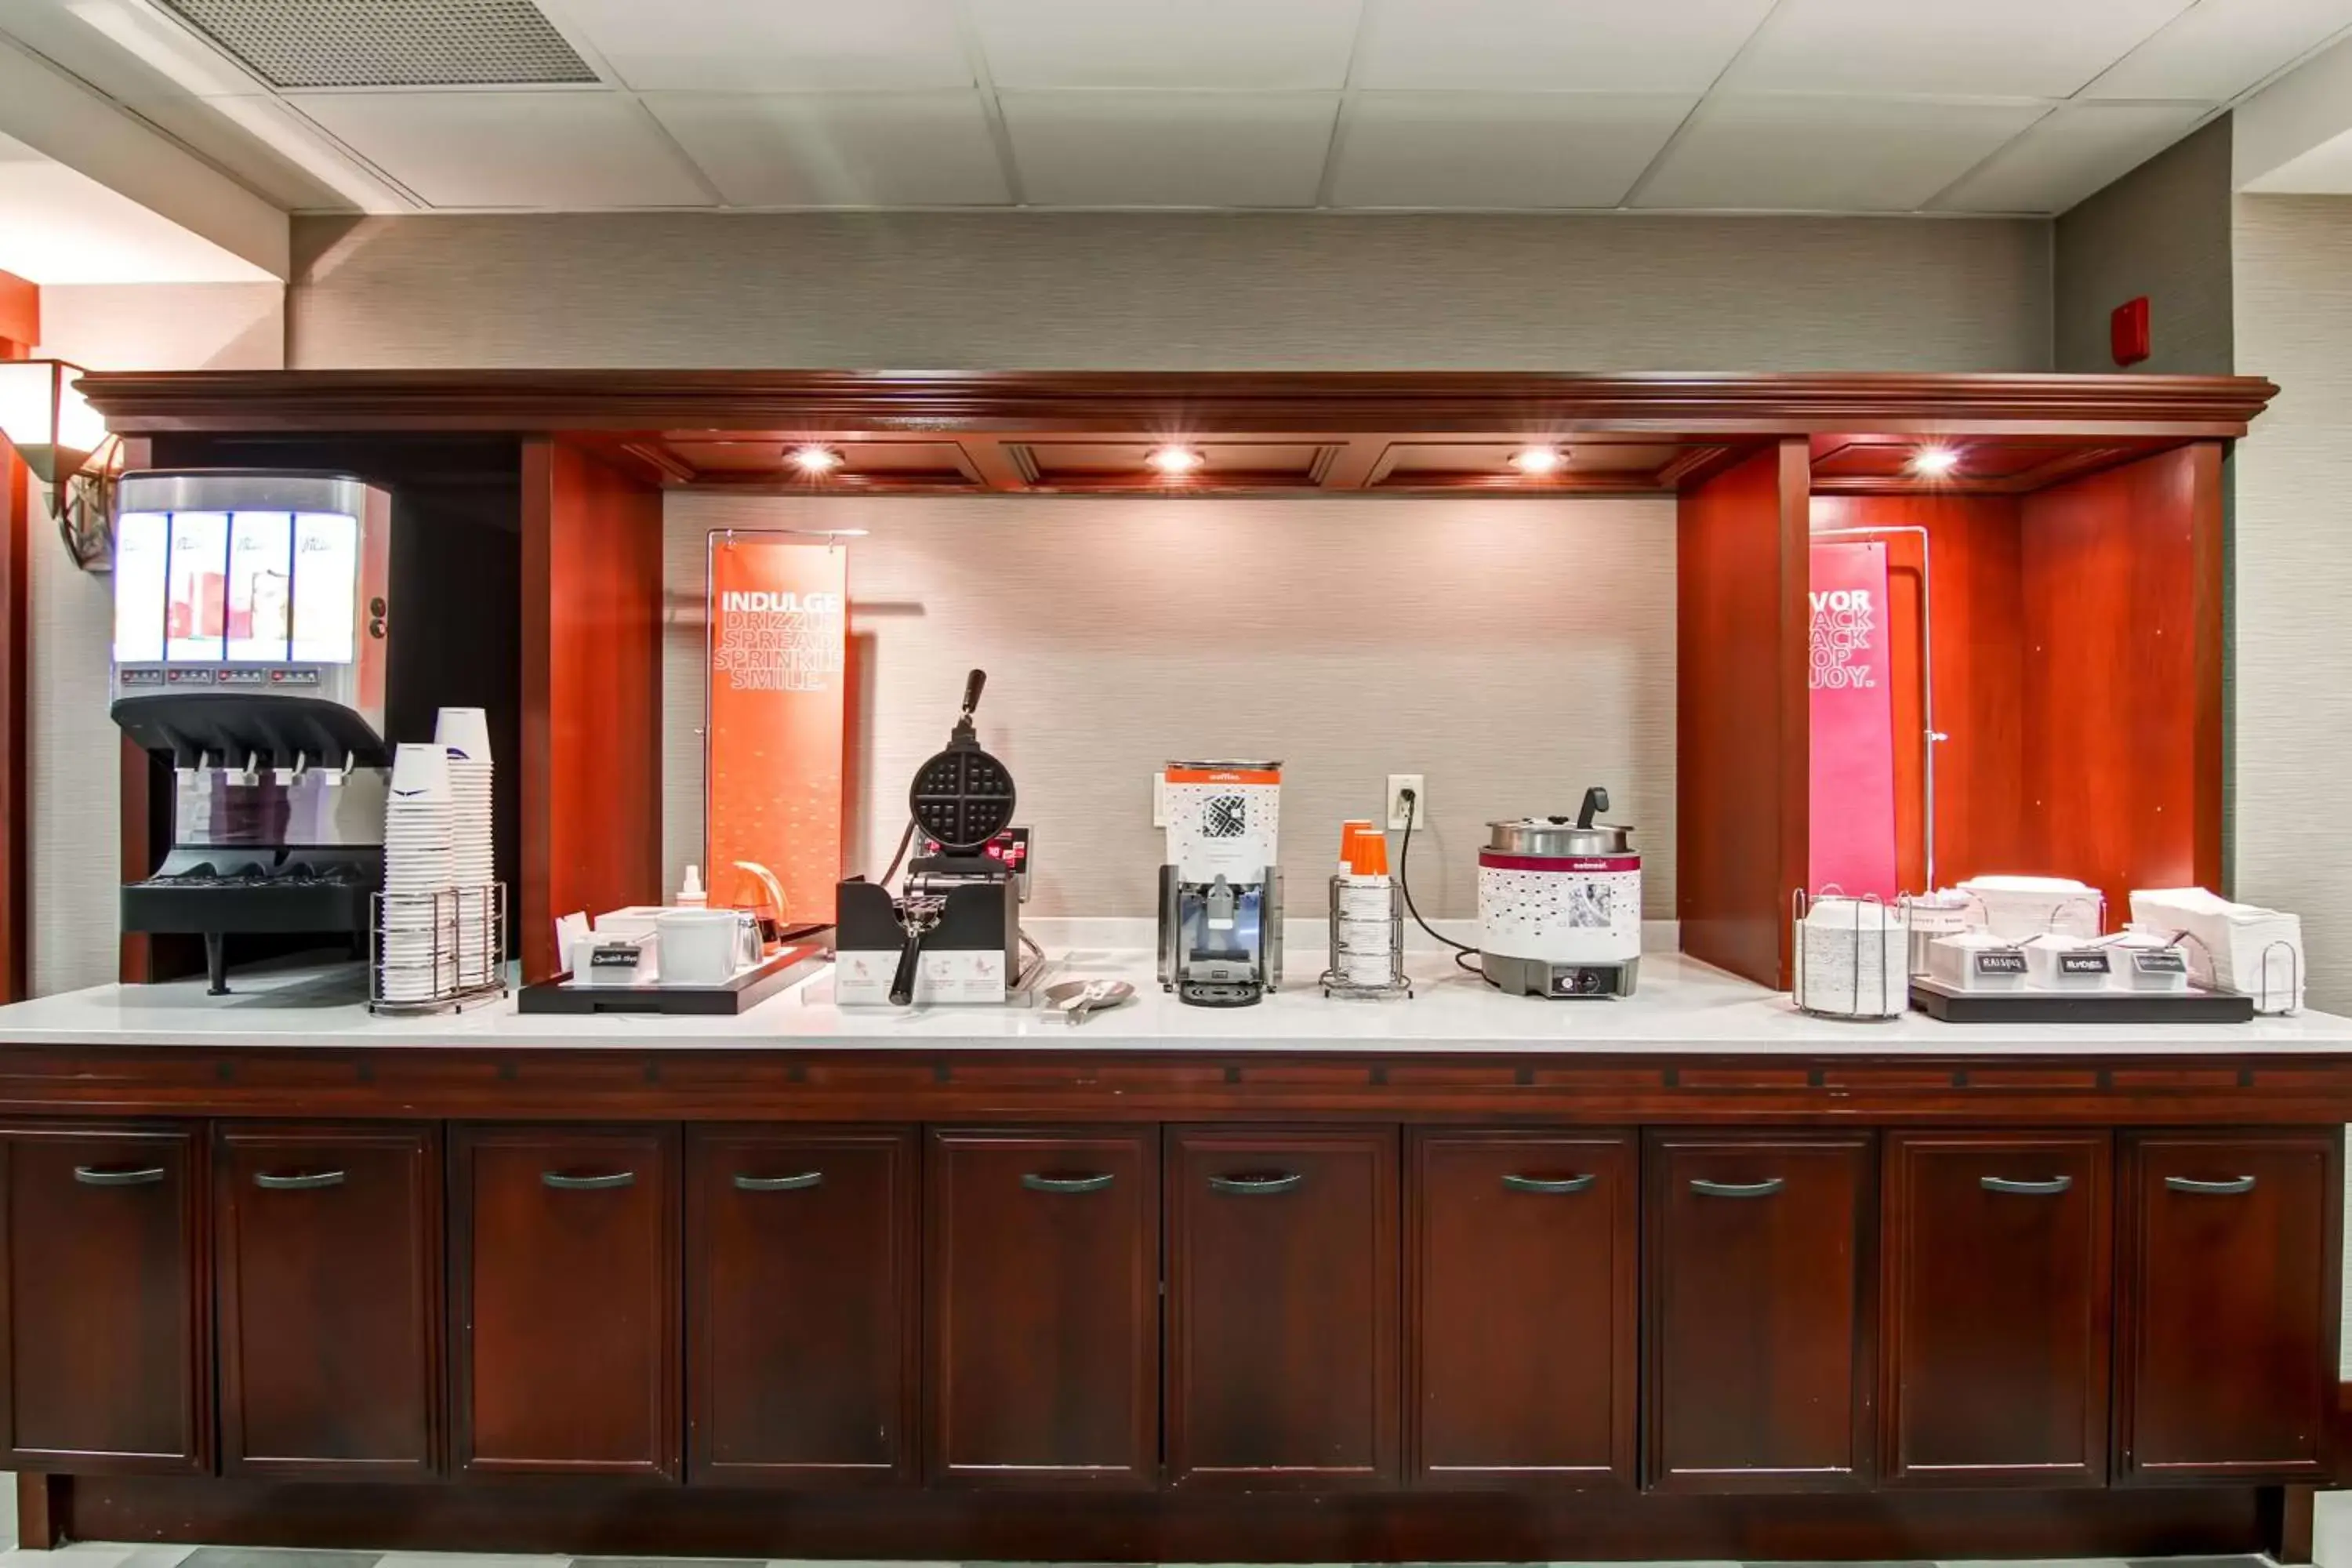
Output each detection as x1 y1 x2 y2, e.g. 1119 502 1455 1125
0 945 2352 1561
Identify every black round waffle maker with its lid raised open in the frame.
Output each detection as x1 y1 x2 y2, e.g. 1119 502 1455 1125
835 670 1028 1006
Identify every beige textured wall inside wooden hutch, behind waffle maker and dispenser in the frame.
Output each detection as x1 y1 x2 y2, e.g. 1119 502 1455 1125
663 492 1675 919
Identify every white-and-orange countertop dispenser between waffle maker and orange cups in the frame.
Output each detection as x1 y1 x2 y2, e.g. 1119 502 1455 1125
1160 762 1282 1006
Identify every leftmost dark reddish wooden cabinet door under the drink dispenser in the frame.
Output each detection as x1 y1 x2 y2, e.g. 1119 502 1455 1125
0 1126 212 1474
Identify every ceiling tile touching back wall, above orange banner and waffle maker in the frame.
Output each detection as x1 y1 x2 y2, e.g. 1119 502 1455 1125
644 92 1011 207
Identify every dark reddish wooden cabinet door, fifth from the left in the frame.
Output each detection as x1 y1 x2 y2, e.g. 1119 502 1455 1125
924 1128 1160 1488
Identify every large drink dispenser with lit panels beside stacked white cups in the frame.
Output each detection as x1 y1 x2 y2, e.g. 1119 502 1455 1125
113 470 393 994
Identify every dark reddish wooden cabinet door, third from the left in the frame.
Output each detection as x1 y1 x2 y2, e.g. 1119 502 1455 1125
449 1126 680 1476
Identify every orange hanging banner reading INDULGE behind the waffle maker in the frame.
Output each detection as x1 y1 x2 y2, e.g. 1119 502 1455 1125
703 532 849 926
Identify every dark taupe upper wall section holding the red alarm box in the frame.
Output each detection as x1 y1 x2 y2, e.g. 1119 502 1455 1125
2053 115 2232 376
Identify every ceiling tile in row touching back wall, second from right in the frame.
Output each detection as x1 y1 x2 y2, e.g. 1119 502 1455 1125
1632 94 2044 212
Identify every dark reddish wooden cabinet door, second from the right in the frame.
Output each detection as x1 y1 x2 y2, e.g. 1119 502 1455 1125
1879 1133 2112 1486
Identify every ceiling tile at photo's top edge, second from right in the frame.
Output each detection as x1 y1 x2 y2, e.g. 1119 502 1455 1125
1724 0 2190 99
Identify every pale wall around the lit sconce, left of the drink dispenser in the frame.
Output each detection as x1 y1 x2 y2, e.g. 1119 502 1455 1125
26 282 285 994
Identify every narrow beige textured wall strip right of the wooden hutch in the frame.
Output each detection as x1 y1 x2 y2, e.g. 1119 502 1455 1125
2232 195 2352 1020
